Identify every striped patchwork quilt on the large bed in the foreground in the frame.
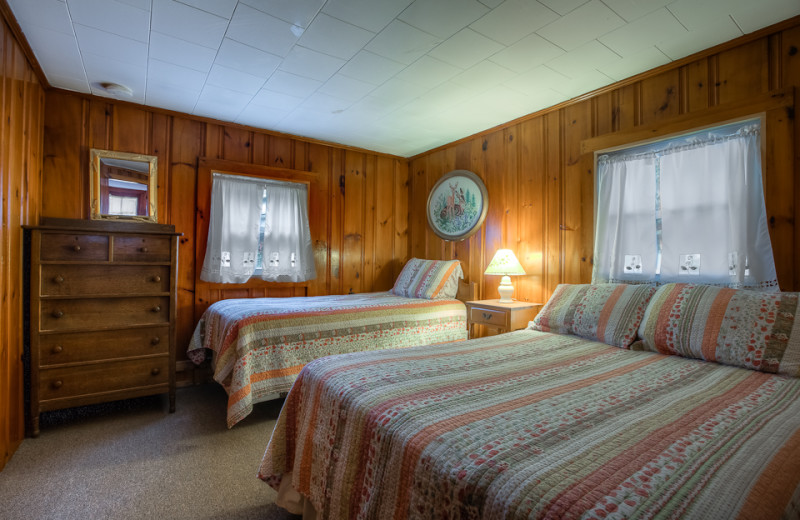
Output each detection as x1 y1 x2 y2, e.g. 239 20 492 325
259 330 800 520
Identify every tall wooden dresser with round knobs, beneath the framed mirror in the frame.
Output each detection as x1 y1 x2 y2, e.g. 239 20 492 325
26 219 179 436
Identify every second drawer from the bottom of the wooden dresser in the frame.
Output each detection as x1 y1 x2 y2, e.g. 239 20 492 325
39 326 169 366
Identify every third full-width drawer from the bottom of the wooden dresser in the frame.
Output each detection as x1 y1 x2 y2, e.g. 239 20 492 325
39 296 169 330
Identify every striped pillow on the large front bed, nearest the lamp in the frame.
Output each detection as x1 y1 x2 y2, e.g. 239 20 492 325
531 283 656 348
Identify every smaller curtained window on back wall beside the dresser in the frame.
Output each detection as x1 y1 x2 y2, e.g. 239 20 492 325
200 173 316 283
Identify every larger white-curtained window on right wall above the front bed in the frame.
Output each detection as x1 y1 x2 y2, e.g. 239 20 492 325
592 120 778 290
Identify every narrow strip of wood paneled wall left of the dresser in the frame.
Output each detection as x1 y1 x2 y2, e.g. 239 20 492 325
0 16 44 470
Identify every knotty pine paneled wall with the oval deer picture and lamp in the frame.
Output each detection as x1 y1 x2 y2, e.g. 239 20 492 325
409 18 800 308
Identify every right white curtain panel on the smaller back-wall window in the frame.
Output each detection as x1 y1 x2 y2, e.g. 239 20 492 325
261 182 316 282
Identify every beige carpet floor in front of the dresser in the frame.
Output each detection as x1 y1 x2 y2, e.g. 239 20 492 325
0 384 299 520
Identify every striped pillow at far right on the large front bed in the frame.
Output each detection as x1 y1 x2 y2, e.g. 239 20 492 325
639 283 800 377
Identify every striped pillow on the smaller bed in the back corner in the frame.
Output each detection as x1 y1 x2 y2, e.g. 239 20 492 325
391 258 464 300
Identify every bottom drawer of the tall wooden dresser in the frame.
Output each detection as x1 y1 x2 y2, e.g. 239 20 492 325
39 356 169 401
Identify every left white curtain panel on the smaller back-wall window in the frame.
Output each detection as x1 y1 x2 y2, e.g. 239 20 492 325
200 174 264 283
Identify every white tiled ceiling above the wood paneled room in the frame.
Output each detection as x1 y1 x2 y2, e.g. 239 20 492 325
8 0 800 156
